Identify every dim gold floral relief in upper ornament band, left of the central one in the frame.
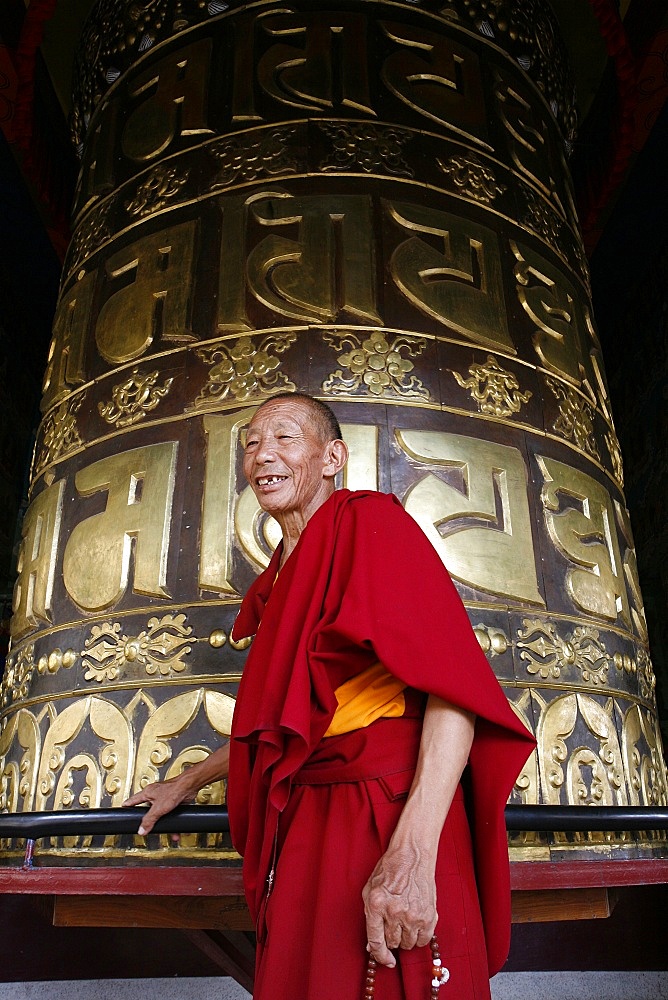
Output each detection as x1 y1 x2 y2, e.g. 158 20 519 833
209 128 299 188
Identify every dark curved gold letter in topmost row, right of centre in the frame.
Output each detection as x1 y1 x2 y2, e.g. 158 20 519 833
381 21 491 148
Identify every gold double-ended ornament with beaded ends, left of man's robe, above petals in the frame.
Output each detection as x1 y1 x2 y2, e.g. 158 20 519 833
81 615 192 682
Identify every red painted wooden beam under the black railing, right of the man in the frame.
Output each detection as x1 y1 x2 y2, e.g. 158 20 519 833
510 858 668 892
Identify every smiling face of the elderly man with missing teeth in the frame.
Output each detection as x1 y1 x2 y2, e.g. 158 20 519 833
244 399 333 519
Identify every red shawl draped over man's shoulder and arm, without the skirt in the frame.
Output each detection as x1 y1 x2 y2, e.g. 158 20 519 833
228 490 534 974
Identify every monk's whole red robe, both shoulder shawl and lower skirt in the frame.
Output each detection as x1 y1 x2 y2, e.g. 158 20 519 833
228 490 533 1000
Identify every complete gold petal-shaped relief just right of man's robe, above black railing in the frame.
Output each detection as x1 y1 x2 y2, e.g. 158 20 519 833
534 694 628 806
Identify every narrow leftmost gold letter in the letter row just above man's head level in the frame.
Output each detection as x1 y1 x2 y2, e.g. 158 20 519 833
42 271 97 413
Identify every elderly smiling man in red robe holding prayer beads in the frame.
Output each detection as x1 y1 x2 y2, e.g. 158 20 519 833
127 393 532 1000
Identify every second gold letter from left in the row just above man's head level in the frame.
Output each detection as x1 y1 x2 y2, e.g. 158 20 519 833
95 222 197 364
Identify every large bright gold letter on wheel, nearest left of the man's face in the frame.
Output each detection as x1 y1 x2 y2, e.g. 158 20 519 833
63 441 177 611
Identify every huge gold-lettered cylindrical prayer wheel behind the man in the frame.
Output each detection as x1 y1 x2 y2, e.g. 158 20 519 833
0 0 666 860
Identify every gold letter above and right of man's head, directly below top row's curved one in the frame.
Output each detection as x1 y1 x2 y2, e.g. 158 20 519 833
387 202 516 354
